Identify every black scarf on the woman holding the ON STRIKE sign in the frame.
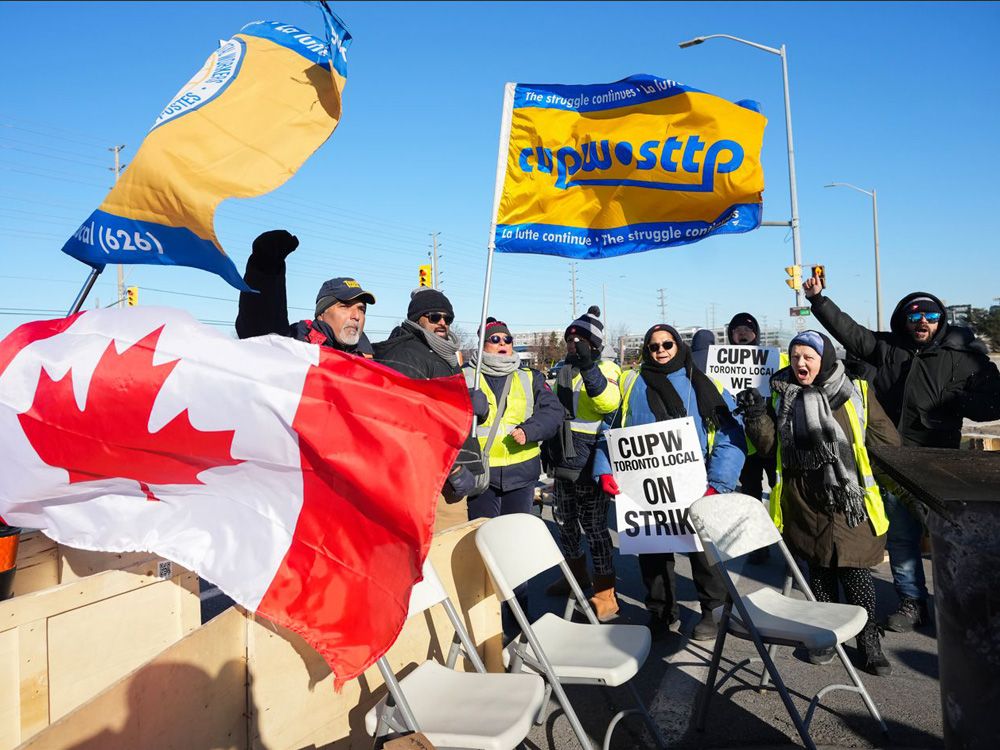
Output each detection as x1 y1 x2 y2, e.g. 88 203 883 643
639 323 733 429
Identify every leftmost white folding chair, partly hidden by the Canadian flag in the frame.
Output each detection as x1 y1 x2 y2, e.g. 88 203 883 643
365 561 545 750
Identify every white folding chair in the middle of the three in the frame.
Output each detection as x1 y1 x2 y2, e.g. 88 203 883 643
476 513 664 750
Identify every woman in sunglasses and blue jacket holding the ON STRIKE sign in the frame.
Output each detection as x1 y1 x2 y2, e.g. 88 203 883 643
594 323 746 640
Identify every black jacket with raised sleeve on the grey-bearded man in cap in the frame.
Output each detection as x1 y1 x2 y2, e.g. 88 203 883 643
236 254 372 356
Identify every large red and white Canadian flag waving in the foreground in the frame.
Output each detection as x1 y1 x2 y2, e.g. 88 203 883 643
0 307 472 686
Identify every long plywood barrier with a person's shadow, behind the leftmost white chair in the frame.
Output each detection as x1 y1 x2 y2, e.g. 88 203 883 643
21 521 502 750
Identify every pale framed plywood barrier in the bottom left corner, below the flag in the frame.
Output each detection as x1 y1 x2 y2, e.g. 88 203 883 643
0 560 201 750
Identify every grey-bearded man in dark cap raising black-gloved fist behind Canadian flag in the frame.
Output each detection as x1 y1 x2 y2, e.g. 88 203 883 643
236 229 375 357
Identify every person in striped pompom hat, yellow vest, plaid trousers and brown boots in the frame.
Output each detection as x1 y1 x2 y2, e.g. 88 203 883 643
542 305 621 621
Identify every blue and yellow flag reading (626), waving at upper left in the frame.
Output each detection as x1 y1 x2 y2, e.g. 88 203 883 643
63 12 351 290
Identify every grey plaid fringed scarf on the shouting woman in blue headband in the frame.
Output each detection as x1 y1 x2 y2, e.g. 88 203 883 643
771 362 868 528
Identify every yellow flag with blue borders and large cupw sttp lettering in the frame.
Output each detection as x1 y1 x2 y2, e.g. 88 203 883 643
494 75 767 259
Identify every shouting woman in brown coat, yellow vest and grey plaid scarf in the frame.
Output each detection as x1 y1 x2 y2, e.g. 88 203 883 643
737 331 900 675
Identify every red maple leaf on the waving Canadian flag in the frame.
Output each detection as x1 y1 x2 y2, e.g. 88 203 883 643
18 326 242 500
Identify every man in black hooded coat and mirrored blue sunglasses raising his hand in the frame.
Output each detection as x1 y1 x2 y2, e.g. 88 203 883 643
803 279 1000 632
